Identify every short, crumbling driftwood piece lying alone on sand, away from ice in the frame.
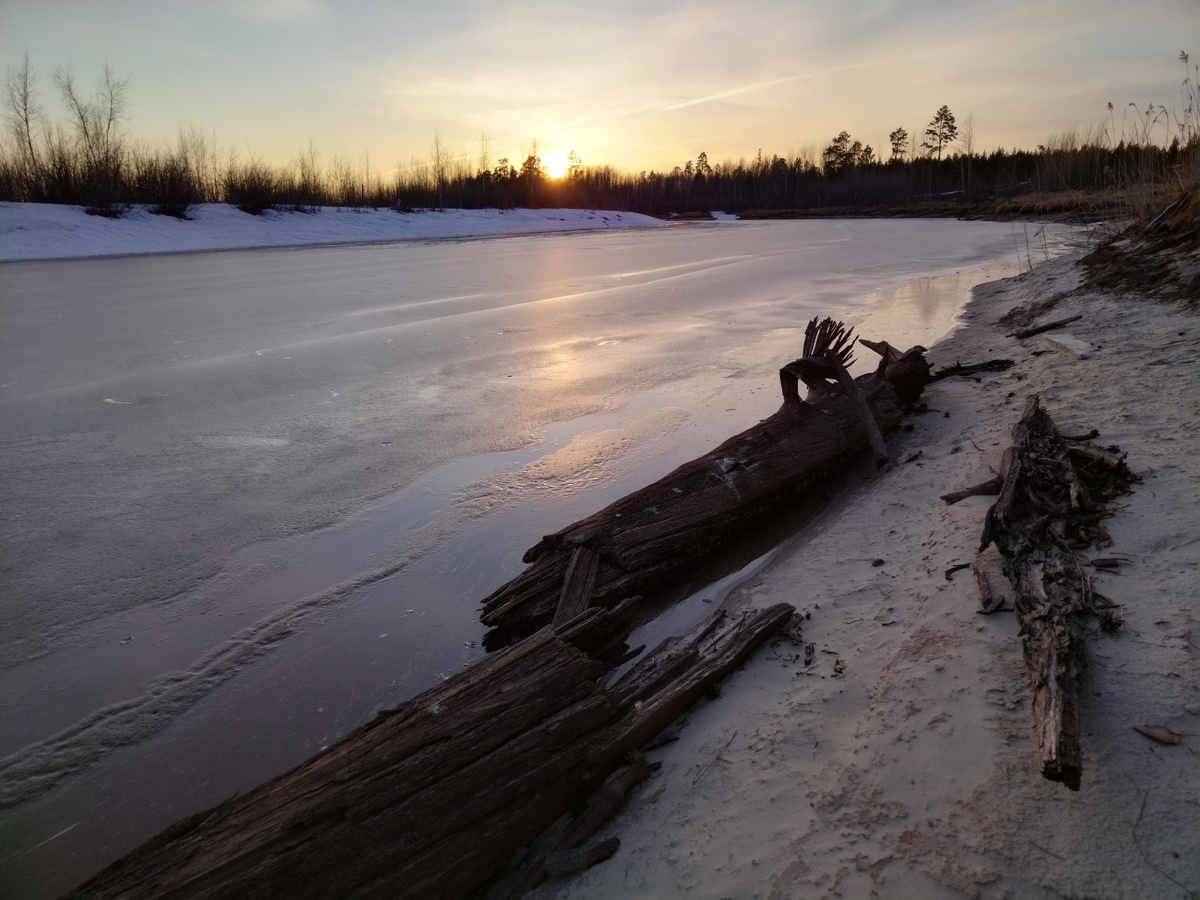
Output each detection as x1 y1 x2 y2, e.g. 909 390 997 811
979 395 1136 791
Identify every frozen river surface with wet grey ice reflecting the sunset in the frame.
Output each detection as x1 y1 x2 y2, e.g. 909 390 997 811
0 220 1070 899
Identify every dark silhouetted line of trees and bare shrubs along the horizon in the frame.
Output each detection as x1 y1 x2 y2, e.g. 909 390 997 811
0 54 1200 217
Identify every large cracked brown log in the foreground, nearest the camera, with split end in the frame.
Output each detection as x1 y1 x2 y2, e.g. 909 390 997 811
68 601 793 900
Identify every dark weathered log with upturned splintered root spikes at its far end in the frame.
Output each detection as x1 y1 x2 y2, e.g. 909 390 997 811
481 319 930 649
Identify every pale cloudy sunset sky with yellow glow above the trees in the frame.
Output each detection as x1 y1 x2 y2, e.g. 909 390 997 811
0 0 1200 173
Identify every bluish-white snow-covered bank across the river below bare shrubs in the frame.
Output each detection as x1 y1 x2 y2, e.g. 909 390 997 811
0 203 664 262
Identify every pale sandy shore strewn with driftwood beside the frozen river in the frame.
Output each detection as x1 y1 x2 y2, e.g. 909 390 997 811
535 237 1200 900
